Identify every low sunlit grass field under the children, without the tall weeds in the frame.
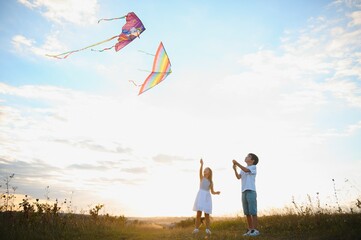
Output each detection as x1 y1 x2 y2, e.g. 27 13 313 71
0 212 361 240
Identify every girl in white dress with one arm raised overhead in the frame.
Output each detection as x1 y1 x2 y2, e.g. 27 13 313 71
193 159 221 234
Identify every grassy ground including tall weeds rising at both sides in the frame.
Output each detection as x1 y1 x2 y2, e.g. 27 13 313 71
0 175 361 240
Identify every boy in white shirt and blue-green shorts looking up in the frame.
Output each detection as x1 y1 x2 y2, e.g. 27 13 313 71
232 153 260 236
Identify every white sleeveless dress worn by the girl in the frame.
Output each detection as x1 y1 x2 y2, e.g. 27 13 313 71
193 177 212 214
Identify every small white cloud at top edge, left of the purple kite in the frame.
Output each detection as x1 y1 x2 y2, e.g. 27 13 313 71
19 0 98 25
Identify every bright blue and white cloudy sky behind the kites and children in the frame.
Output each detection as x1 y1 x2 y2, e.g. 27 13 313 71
0 0 361 217
